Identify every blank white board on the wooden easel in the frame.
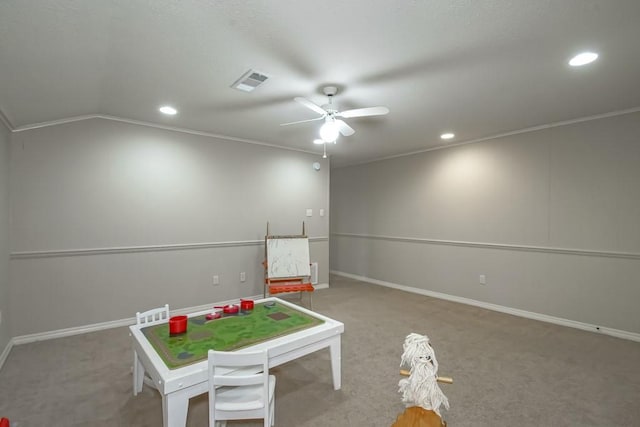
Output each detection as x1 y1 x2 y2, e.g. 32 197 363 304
267 236 311 279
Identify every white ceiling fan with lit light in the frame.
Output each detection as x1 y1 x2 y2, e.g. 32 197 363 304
280 86 389 144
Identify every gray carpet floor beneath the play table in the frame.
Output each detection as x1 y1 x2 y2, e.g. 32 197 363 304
0 277 640 427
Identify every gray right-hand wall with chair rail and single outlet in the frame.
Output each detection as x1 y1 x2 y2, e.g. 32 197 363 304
331 113 640 333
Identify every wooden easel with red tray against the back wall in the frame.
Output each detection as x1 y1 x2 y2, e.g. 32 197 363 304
263 222 314 309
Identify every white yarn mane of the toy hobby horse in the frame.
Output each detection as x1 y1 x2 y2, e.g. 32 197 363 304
398 333 449 416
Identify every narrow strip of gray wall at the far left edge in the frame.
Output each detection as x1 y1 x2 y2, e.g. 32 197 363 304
0 121 12 354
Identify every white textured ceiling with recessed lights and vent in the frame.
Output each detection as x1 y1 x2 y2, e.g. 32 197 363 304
0 0 640 165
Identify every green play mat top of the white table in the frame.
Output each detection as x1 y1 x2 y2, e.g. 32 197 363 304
141 303 324 369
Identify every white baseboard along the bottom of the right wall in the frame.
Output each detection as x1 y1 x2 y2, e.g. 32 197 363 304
330 270 640 342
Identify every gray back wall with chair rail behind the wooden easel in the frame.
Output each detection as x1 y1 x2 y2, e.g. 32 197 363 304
10 119 329 336
